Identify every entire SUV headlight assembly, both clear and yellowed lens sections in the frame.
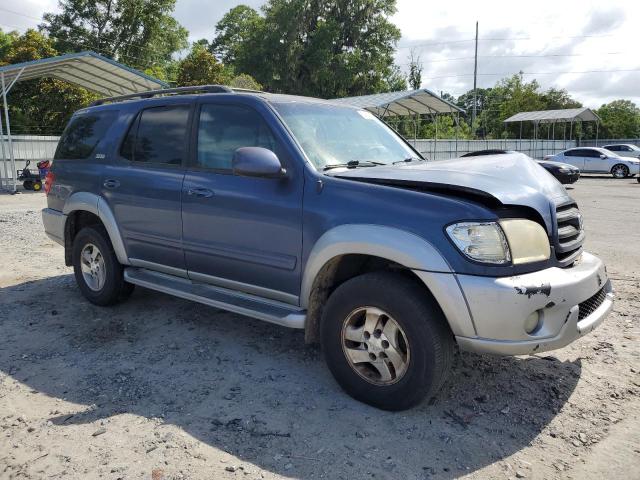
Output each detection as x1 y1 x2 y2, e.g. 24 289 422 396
447 218 551 265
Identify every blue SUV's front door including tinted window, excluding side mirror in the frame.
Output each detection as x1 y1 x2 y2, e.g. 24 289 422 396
182 99 303 303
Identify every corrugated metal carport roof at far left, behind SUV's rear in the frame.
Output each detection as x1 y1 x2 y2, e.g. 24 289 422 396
0 51 168 96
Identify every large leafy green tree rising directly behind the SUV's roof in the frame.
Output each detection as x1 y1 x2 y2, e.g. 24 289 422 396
212 0 406 98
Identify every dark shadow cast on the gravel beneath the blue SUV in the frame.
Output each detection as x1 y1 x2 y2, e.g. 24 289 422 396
0 275 581 479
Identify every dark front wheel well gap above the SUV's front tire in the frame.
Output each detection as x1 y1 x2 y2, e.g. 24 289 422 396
305 254 444 343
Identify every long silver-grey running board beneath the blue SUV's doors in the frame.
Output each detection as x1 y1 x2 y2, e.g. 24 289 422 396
124 267 306 328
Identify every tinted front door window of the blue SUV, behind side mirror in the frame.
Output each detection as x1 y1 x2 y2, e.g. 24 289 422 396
196 104 277 170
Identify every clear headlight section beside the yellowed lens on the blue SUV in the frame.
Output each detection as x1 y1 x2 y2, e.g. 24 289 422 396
447 222 511 265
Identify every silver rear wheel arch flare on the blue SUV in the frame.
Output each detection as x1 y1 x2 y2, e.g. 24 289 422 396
62 192 129 265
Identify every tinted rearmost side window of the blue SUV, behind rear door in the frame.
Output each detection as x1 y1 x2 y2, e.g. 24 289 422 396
53 110 118 160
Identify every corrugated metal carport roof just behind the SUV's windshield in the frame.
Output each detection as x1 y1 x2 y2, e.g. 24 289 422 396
331 88 465 117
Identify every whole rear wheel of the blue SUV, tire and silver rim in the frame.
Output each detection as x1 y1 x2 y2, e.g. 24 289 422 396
72 226 134 306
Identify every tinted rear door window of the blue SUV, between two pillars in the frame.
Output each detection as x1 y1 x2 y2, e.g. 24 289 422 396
121 105 190 165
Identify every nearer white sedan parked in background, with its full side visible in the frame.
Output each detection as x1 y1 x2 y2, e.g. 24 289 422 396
544 147 640 178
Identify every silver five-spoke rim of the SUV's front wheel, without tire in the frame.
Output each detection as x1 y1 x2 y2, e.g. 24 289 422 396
342 307 410 385
